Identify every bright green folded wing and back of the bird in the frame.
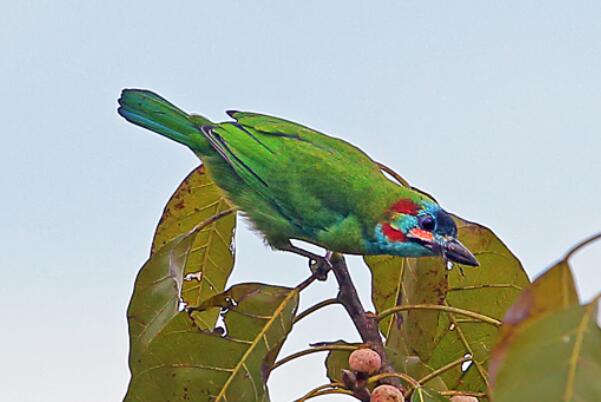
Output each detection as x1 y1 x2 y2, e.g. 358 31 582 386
203 112 396 237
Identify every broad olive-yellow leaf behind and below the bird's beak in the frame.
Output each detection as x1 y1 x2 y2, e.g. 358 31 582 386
365 218 529 392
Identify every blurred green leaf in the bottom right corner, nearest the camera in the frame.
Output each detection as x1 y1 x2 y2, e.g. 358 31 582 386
493 300 601 402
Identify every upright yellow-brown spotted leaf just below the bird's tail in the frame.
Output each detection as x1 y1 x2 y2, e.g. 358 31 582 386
152 165 236 330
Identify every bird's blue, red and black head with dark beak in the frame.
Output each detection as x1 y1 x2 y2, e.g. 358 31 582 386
375 197 478 266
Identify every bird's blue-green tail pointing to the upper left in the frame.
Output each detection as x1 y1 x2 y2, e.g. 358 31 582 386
117 89 212 154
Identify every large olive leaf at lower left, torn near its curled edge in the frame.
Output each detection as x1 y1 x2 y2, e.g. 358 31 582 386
125 228 298 402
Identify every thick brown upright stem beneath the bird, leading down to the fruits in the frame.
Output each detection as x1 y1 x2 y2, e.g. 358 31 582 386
331 253 405 401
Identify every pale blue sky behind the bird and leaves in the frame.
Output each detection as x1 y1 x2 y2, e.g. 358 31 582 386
0 0 601 402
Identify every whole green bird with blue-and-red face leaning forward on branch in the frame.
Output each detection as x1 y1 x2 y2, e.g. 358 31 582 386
118 89 478 266
